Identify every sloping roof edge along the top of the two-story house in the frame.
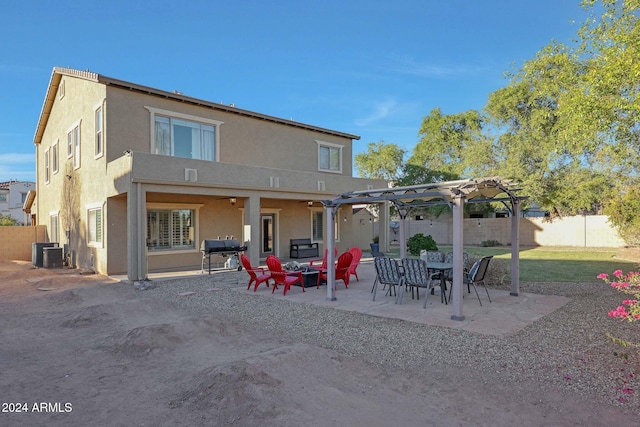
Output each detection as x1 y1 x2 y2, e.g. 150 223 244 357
33 67 360 144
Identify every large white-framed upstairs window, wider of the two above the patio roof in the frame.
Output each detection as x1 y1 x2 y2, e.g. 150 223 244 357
145 107 223 162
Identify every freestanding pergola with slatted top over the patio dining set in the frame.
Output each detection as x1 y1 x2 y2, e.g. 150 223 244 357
322 177 527 320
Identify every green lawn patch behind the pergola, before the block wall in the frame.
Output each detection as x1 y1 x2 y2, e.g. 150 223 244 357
378 246 639 283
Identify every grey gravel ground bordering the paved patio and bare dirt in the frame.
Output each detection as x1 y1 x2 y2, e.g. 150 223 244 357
144 272 640 415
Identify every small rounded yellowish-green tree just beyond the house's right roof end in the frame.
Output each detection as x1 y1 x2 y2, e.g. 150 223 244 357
354 141 405 181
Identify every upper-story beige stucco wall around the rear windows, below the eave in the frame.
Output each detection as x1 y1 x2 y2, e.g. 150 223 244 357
107 87 352 176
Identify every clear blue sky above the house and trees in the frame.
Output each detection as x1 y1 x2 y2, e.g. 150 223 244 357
0 0 585 181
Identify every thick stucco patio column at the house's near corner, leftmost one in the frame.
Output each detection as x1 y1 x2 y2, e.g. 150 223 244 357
127 183 147 282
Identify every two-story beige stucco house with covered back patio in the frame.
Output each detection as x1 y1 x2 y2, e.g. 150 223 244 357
32 68 386 280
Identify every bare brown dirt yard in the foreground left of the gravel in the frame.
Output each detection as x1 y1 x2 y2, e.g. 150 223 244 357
0 261 637 426
